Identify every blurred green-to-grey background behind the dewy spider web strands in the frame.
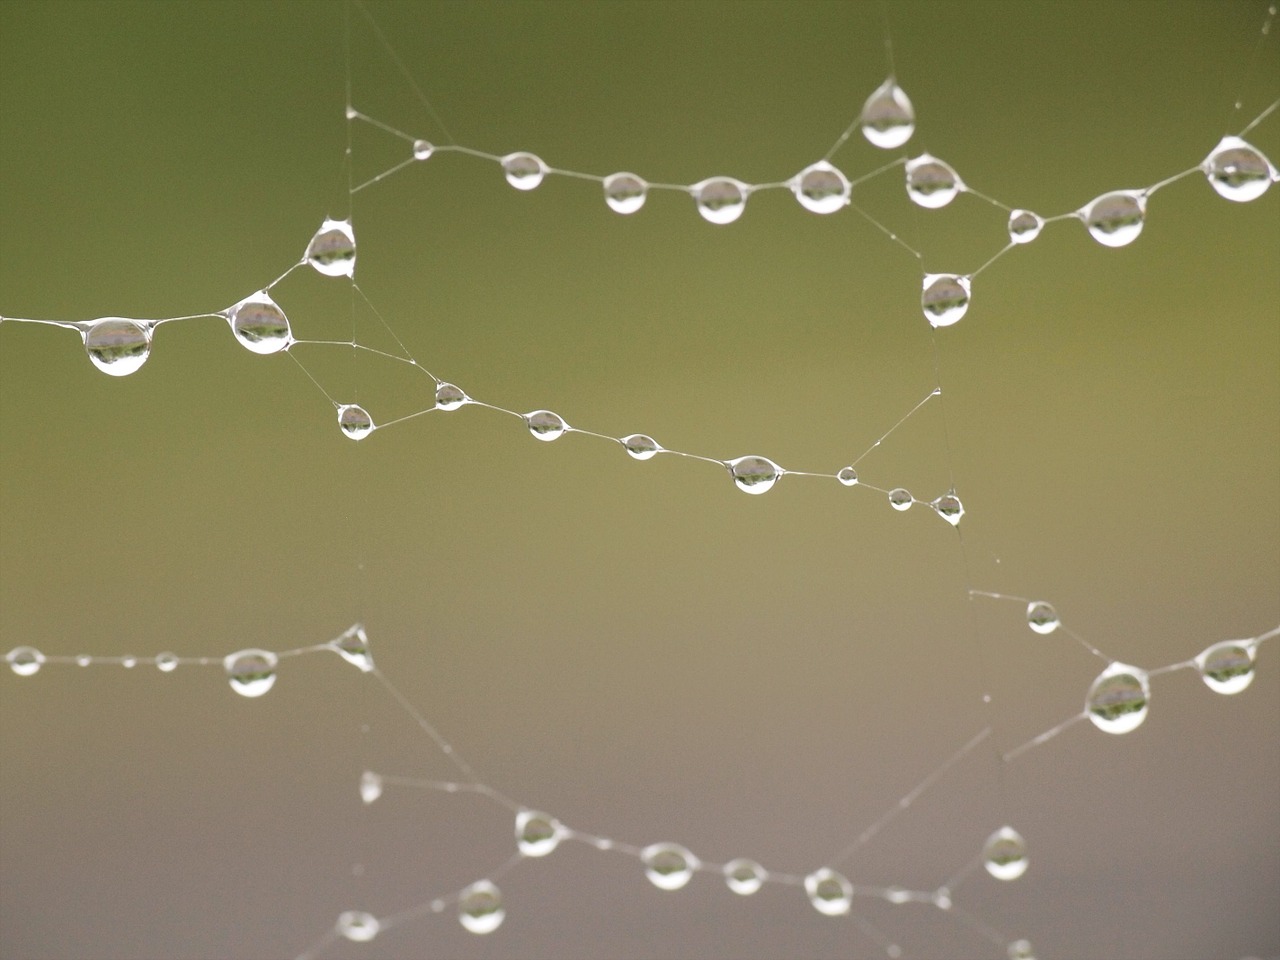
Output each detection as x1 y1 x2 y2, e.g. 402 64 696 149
0 1 1280 959
